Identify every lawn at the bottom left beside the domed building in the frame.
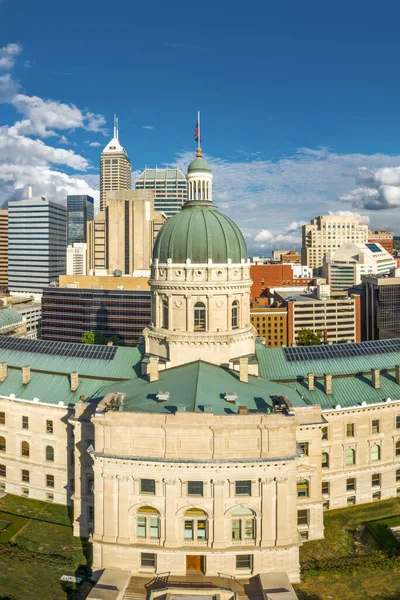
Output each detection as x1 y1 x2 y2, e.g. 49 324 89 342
0 494 90 600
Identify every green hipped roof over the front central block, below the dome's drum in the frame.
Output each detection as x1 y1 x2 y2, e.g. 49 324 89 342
97 361 305 415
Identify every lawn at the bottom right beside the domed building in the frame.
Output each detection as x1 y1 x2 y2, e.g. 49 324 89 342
296 499 400 600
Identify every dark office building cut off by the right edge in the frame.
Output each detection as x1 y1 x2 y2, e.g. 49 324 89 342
362 275 400 341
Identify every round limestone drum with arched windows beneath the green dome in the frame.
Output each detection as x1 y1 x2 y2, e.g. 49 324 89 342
143 261 256 367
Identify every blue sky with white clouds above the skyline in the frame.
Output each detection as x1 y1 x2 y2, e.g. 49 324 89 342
0 0 400 253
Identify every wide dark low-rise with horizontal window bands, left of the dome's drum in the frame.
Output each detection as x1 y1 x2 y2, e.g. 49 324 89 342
41 288 151 346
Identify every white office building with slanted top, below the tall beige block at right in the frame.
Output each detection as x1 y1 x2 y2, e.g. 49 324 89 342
323 243 396 296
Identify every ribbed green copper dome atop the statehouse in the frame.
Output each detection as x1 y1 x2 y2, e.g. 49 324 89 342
153 201 247 264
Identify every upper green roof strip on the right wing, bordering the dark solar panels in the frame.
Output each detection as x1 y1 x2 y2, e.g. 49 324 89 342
256 342 400 381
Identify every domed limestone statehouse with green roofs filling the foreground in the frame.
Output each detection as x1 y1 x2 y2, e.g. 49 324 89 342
0 149 400 597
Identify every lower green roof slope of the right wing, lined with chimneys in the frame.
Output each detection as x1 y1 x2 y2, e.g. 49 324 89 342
285 373 400 410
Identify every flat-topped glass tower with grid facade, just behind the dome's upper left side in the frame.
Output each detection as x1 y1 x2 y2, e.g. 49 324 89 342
135 169 187 217
